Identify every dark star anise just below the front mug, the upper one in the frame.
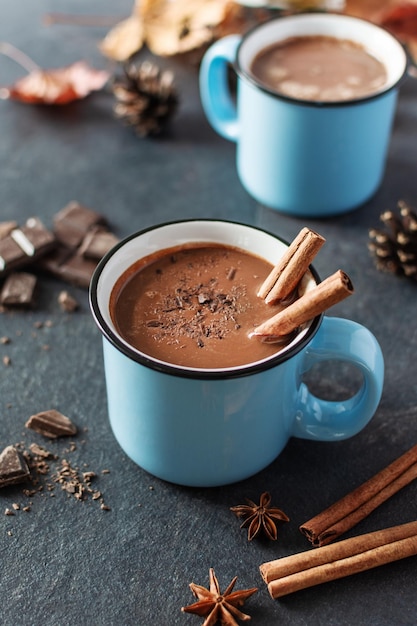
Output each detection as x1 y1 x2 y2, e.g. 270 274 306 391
230 491 290 541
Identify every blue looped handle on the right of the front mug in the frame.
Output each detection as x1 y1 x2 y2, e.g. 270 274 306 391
292 316 384 441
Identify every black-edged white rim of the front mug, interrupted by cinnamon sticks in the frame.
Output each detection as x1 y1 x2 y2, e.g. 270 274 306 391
89 218 323 380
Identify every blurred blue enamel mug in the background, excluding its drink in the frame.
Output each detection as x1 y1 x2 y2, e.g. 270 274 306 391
200 13 407 217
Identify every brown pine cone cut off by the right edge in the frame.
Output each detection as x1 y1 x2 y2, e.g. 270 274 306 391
368 200 417 280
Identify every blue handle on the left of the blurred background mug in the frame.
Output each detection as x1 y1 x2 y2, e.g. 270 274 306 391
200 35 242 141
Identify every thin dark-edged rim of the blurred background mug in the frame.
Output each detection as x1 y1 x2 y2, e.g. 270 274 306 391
234 12 410 108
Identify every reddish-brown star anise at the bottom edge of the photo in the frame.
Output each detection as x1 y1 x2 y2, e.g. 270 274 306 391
181 568 258 626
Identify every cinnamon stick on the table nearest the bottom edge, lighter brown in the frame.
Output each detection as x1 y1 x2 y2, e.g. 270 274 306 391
260 521 417 599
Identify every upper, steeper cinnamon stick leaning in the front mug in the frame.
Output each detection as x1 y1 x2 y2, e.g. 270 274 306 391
258 228 325 304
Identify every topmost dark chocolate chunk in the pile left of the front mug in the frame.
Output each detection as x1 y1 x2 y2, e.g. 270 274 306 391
54 202 105 248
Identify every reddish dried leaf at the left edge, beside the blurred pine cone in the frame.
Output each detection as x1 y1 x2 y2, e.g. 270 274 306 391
1 61 110 104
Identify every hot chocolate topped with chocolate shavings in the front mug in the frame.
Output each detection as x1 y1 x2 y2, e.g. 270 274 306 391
110 243 294 369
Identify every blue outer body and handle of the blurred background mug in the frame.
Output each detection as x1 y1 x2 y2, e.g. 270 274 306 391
200 35 398 217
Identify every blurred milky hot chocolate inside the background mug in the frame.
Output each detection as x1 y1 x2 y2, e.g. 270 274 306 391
251 35 387 102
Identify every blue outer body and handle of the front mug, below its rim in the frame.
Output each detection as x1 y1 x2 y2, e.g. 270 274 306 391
99 318 384 487
